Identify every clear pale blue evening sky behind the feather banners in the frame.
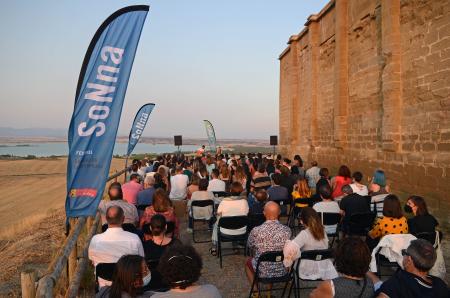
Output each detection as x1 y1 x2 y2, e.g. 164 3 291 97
0 0 328 139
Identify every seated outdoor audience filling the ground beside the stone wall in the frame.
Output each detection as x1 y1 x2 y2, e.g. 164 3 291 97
89 151 448 297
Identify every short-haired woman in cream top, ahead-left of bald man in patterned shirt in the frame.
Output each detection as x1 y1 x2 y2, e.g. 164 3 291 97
210 182 249 255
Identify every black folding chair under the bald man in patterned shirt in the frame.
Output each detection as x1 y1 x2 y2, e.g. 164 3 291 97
248 251 293 298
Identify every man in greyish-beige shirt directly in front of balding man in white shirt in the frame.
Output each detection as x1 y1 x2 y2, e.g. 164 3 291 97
98 182 139 226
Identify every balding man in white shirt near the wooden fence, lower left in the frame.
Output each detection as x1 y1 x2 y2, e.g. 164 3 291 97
88 206 144 287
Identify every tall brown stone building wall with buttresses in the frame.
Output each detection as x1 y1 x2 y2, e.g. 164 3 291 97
279 0 450 227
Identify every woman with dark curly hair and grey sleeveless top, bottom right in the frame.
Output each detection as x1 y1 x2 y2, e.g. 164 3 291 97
310 237 375 298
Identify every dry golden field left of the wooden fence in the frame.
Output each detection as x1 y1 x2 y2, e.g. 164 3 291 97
0 158 124 297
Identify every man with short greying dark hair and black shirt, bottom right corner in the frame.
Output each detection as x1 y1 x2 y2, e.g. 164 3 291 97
370 239 450 298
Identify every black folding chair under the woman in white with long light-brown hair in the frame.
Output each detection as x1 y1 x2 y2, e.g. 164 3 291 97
288 249 333 297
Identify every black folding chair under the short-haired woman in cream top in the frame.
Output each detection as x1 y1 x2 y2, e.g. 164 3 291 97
217 216 248 268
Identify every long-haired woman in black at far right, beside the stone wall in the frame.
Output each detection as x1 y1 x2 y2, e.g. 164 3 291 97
404 196 439 235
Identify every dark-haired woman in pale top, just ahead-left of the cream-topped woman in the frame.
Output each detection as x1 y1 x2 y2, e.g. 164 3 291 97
187 178 214 232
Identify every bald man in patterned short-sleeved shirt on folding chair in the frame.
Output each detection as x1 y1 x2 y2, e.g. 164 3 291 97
245 202 291 284
